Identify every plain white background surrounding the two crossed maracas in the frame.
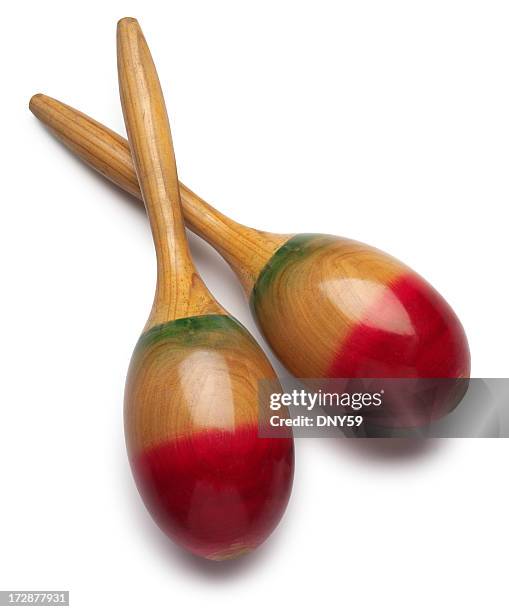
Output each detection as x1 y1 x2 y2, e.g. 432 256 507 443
0 0 509 612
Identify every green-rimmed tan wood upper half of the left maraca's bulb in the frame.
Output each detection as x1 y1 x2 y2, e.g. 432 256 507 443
125 315 275 452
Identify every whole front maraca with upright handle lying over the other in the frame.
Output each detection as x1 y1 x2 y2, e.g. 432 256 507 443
117 18 294 559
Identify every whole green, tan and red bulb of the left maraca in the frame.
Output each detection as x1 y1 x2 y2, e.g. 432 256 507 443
125 315 294 560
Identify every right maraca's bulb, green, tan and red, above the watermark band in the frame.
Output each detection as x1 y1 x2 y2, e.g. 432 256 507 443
251 234 470 378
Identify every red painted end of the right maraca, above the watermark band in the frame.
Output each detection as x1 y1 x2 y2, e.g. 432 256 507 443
328 274 470 378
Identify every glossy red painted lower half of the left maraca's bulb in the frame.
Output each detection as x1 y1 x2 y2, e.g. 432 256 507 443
131 427 294 559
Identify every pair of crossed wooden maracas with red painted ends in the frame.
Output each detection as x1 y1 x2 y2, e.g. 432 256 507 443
30 19 470 559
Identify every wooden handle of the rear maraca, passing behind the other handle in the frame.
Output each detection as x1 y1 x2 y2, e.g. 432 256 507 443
30 94 291 296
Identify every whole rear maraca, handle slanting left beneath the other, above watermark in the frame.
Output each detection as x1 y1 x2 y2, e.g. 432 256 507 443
30 87 470 388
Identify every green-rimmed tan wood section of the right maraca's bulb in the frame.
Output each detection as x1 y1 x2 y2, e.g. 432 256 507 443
251 235 403 378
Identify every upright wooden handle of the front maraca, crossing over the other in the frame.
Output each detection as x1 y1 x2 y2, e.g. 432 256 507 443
117 18 219 328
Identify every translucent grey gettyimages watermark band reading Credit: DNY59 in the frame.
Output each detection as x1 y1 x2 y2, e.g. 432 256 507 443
259 378 509 438
